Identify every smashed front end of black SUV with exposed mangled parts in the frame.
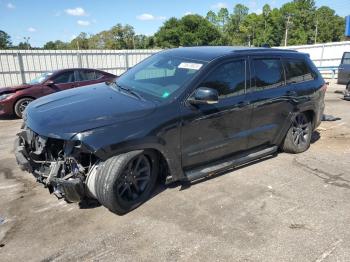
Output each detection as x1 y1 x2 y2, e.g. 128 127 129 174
15 127 98 202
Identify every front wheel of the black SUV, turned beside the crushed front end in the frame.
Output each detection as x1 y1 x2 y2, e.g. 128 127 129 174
95 151 159 215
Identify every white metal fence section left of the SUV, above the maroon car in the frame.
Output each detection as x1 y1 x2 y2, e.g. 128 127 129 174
0 49 160 87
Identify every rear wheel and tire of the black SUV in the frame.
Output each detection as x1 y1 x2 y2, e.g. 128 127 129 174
282 113 312 154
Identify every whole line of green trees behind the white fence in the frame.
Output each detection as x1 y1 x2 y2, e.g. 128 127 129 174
4 0 345 49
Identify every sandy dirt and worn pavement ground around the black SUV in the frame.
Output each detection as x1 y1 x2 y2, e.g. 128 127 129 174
0 81 350 261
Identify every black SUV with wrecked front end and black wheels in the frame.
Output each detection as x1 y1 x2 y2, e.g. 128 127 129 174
15 47 326 214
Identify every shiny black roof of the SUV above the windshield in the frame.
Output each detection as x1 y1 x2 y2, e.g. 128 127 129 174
163 46 296 62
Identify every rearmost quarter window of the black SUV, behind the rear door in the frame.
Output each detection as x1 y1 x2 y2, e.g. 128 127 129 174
284 59 314 84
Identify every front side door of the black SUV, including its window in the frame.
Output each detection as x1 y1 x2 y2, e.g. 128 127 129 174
182 59 252 168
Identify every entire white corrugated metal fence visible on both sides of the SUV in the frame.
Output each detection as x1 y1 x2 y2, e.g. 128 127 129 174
0 41 350 87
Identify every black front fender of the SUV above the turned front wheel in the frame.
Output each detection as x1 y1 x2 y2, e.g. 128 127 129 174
72 111 184 181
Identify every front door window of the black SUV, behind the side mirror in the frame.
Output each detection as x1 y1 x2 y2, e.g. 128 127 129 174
201 60 246 98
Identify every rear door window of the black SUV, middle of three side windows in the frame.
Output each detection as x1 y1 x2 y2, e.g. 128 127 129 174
252 58 284 91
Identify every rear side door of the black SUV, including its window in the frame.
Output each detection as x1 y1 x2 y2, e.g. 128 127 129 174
248 56 294 148
